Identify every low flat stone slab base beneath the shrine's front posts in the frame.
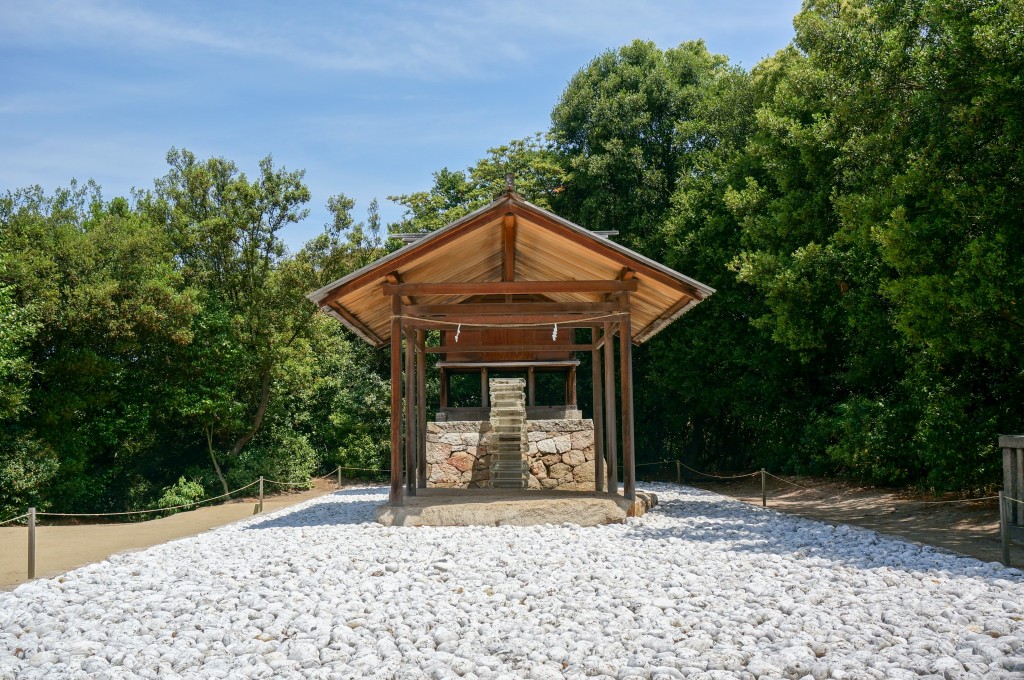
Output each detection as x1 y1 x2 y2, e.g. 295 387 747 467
377 488 657 526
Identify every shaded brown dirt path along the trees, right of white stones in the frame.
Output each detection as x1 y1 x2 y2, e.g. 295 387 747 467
687 476 1024 568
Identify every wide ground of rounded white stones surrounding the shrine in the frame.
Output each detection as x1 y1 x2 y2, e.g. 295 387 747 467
0 484 1024 678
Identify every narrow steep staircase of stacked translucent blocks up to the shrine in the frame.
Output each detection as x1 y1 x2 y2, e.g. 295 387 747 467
487 378 529 488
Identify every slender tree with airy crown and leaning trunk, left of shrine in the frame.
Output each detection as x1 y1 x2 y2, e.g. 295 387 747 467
140 148 314 493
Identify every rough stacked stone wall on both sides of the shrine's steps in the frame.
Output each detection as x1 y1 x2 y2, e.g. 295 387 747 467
427 420 594 491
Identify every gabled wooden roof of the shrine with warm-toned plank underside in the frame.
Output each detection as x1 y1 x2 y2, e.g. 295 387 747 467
306 190 715 346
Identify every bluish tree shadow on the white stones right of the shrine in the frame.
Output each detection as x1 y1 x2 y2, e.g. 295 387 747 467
626 493 1024 582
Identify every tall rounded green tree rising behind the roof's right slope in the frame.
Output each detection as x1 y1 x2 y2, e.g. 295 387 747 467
550 40 727 258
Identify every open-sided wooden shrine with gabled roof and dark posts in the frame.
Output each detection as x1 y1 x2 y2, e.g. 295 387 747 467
307 186 714 505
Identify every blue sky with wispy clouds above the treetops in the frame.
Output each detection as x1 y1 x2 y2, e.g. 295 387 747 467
0 0 800 248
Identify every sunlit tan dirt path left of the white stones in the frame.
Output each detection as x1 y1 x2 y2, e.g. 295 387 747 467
0 479 337 590
